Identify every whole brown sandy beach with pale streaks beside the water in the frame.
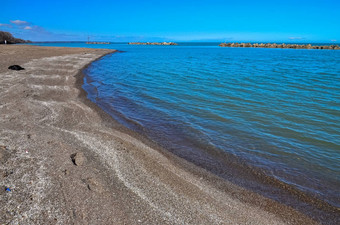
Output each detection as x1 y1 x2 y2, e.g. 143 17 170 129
0 45 315 224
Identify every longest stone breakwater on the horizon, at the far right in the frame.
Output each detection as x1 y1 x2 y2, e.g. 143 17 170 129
219 43 340 50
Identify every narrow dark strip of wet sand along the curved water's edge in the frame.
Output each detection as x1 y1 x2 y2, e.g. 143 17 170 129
76 53 307 224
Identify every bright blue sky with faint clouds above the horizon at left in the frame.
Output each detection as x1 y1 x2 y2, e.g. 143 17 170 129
0 0 340 43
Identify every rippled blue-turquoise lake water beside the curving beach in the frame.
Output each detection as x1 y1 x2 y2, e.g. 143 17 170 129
33 44 340 213
